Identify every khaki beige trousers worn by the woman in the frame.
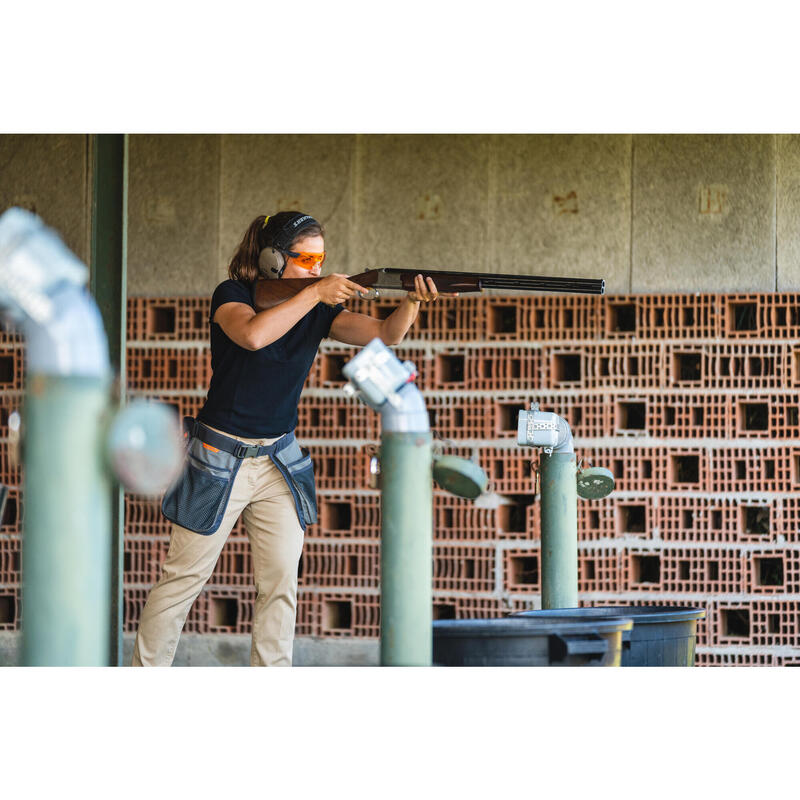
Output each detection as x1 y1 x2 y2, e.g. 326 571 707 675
132 431 303 667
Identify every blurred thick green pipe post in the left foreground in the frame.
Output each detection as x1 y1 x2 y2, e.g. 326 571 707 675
22 374 111 666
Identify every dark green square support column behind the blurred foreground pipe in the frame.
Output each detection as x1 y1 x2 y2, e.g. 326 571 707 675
89 134 128 666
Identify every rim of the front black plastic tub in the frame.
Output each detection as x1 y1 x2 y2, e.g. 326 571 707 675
433 614 633 636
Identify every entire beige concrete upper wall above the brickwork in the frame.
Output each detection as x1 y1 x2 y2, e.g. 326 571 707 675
0 134 800 296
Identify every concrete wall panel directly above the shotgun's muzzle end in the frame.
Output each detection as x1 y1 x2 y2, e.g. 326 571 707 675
489 135 631 292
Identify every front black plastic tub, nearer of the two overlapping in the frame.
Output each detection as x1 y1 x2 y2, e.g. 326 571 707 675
433 615 633 667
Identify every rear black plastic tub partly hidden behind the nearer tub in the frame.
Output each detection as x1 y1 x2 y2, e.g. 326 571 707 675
509 606 706 667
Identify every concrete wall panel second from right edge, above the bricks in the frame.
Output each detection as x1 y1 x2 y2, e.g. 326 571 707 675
632 135 776 292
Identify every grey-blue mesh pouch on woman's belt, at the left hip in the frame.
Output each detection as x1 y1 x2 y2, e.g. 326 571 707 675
161 439 241 536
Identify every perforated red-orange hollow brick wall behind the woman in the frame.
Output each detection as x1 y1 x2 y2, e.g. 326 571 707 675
0 294 800 666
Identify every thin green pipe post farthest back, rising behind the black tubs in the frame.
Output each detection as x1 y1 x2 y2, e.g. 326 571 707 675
540 453 578 608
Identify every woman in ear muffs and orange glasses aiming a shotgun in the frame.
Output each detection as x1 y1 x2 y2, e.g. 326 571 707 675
133 211 438 666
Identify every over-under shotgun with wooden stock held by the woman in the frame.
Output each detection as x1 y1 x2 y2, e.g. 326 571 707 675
253 267 605 311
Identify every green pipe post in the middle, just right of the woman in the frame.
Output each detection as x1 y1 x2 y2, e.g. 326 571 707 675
381 431 433 667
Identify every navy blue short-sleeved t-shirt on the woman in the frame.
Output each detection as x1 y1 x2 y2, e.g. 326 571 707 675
197 280 343 439
